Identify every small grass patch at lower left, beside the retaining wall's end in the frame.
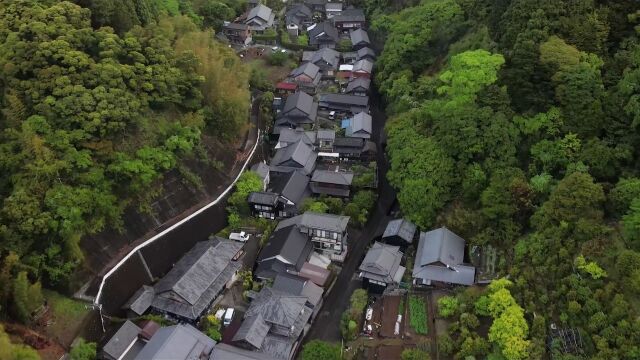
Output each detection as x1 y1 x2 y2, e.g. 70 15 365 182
42 289 89 345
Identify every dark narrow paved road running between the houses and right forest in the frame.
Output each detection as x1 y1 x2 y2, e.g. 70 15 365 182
305 88 395 342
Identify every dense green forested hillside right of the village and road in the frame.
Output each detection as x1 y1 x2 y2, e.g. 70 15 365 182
363 0 640 359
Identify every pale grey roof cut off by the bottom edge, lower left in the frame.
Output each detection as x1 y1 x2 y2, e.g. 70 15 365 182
136 324 216 360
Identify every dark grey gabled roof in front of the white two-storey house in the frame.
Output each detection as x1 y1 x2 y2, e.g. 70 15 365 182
258 226 313 270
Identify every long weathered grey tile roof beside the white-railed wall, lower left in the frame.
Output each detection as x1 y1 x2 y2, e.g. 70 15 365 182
152 238 242 320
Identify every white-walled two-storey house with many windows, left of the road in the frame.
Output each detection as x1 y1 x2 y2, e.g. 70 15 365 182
276 211 349 255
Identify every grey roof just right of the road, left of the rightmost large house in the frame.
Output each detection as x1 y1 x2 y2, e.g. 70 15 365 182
359 242 405 284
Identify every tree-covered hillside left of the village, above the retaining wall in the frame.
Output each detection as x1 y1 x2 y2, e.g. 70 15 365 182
0 0 250 318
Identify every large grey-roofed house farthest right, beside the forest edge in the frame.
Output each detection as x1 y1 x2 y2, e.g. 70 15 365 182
413 227 475 285
